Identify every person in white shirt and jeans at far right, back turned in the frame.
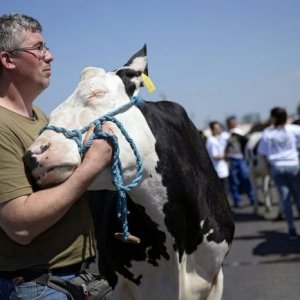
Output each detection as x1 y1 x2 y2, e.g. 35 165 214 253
258 107 300 239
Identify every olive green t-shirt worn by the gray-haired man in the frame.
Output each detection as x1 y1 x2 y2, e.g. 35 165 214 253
0 106 95 271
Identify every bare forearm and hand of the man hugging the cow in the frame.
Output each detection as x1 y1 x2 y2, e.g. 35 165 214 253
0 139 112 245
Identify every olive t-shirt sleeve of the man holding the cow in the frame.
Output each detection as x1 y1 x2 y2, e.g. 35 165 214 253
0 132 32 203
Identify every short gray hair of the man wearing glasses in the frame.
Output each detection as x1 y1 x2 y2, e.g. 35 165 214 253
0 14 42 51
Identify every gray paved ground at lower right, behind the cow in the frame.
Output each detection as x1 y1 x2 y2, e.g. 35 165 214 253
223 200 300 300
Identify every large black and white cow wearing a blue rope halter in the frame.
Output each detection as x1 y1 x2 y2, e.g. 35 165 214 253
24 46 234 300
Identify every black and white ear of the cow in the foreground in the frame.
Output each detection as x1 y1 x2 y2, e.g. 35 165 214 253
116 44 148 98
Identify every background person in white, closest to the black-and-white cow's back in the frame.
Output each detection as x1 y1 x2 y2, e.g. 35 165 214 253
206 121 229 193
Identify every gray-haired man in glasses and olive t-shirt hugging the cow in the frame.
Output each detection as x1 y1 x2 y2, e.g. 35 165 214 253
0 14 112 300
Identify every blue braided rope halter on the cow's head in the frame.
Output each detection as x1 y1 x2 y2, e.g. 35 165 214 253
40 96 144 242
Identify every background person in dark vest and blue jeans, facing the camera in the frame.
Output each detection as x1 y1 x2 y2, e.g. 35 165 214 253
225 116 255 207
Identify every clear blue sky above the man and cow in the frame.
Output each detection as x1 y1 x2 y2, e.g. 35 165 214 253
0 0 300 129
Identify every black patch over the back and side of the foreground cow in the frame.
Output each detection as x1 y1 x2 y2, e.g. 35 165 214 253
141 101 234 253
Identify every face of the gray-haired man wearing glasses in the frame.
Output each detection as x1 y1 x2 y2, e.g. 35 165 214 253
12 31 53 93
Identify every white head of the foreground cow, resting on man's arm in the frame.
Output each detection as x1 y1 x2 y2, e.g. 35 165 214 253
24 45 147 187
